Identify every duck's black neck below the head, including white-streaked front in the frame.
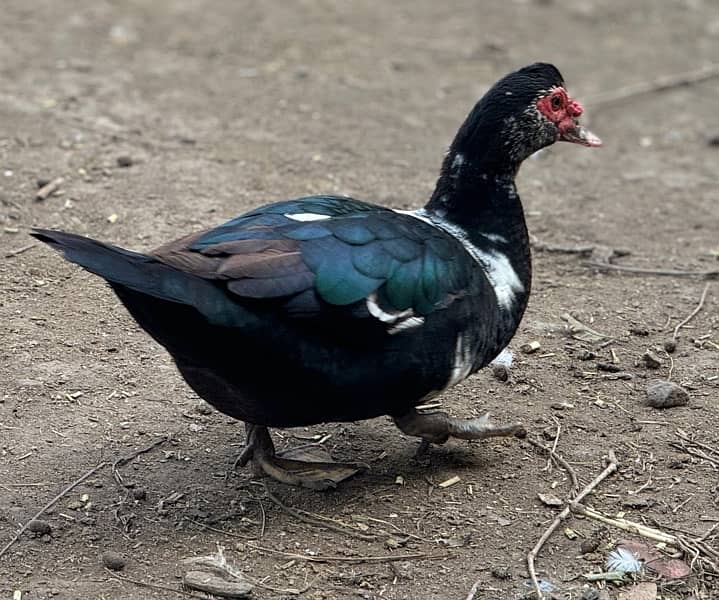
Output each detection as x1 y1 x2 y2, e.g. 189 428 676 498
425 150 531 342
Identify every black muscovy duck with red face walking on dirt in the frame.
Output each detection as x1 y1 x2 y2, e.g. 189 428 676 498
32 63 601 489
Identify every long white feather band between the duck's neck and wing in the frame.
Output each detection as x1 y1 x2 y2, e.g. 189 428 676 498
396 208 524 311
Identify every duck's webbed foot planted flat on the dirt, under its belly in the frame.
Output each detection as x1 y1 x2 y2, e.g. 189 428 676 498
235 423 361 490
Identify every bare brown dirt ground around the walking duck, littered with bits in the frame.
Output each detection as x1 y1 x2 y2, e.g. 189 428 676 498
0 0 719 600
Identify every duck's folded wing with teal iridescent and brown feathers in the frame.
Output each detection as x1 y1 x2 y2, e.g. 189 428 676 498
155 196 473 316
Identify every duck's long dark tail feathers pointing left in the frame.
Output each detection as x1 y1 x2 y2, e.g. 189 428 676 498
30 229 247 325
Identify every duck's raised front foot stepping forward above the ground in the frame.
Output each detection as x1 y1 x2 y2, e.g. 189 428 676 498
394 409 527 448
